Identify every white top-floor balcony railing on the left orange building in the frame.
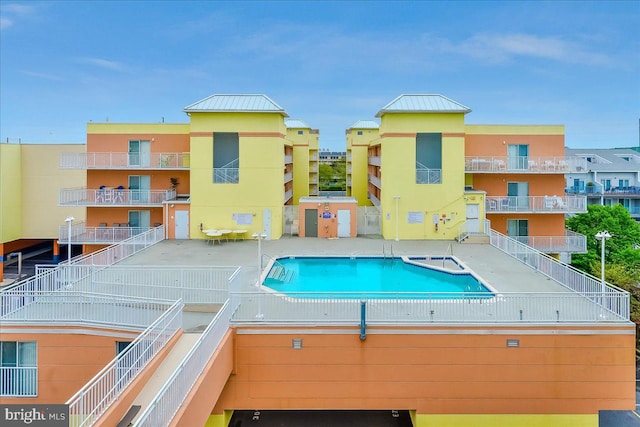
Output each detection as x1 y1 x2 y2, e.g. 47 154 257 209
60 153 191 170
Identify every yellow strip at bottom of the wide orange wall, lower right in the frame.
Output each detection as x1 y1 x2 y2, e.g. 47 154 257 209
411 414 598 427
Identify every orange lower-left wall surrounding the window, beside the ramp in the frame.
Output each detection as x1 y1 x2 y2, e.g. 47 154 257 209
2 326 141 403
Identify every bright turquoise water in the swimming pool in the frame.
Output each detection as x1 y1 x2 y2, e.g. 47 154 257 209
264 257 493 299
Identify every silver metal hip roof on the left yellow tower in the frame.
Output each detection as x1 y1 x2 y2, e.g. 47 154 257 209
184 95 289 117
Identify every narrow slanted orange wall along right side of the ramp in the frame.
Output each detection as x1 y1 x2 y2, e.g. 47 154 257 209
170 330 234 427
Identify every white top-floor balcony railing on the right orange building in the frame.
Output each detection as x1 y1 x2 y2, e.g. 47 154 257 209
464 156 587 174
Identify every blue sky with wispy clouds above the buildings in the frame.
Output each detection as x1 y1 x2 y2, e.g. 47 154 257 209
0 0 640 149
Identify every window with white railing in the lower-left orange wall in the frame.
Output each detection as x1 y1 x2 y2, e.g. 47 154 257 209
0 341 38 396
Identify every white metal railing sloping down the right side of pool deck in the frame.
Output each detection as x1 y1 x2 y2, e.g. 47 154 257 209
491 230 630 320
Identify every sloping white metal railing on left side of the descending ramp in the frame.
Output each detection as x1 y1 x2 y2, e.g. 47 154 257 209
66 301 184 427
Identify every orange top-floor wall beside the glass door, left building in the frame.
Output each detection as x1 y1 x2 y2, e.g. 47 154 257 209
87 133 190 153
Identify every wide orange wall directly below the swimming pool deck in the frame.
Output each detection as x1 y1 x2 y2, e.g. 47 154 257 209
213 325 635 414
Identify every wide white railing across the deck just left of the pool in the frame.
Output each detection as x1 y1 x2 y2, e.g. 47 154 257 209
74 265 239 304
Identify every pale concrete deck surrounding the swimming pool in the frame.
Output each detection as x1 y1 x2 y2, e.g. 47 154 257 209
120 237 570 292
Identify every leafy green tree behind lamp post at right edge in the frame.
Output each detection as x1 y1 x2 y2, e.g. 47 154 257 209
567 205 640 271
